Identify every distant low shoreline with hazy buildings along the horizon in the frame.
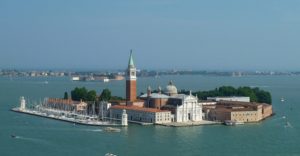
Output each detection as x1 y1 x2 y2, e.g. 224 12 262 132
0 69 300 80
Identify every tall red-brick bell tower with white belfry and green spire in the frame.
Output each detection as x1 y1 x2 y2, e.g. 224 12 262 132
126 50 136 104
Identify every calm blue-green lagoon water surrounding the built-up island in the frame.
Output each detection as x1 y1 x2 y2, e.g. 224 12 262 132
0 76 300 156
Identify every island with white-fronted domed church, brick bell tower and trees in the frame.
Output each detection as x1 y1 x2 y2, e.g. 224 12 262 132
12 52 273 126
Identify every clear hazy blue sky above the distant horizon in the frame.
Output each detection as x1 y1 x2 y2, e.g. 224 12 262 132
0 0 300 70
